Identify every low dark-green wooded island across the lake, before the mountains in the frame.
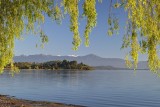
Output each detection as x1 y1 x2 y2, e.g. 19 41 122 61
14 60 93 70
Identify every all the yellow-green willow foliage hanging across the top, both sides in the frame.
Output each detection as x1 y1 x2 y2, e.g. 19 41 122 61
0 0 160 73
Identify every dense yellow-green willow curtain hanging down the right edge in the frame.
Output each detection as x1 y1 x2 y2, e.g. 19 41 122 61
121 0 160 73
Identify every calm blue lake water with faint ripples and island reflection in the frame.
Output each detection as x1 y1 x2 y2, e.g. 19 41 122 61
0 70 160 107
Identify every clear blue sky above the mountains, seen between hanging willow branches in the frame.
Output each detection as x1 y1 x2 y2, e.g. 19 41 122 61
15 0 146 60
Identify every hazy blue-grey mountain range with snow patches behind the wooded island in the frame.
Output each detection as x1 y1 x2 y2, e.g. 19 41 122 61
14 54 148 69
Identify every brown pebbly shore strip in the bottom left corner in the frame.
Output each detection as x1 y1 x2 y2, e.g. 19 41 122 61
0 94 85 107
